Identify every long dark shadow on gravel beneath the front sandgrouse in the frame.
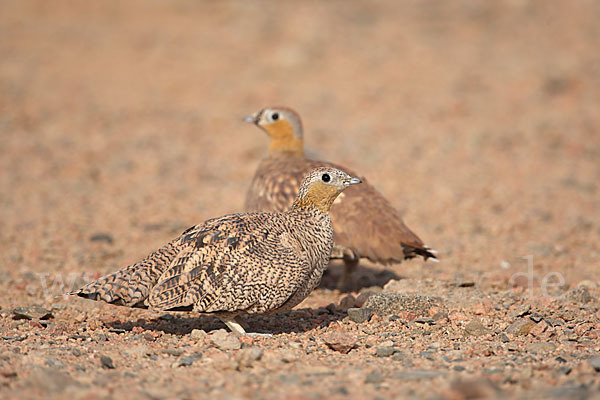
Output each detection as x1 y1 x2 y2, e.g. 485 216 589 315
106 307 347 336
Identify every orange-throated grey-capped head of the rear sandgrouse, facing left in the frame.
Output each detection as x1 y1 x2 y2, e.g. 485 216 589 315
244 107 304 155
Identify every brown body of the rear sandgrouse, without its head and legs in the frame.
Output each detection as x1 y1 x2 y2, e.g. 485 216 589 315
246 157 436 264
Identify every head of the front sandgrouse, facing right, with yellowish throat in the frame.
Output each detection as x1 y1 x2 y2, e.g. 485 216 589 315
292 167 361 213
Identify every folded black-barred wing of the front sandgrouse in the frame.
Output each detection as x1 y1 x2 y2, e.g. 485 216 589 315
149 213 310 312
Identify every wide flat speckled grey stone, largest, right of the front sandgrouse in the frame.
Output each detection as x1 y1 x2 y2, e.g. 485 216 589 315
365 292 444 317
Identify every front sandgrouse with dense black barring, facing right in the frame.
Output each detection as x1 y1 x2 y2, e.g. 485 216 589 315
70 167 360 334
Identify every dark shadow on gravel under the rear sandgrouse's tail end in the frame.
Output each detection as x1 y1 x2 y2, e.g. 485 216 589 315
319 262 405 293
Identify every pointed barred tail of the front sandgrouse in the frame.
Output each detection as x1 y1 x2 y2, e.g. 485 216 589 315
68 240 180 307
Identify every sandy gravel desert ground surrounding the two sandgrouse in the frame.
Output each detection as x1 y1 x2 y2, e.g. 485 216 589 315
0 0 600 400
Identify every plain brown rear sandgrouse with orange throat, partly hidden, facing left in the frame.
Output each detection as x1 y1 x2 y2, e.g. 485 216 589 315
245 107 437 286
